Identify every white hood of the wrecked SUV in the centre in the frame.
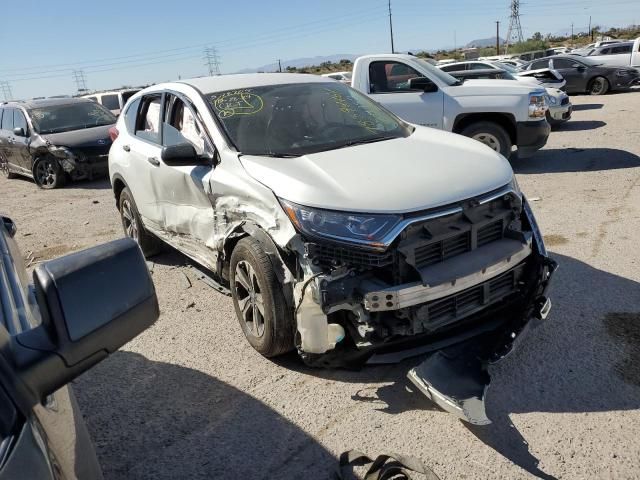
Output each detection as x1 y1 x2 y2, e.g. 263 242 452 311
240 127 513 213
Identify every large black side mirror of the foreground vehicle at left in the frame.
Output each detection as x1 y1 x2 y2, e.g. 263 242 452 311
13 238 159 405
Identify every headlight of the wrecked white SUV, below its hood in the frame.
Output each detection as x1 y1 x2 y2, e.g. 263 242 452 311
280 199 401 249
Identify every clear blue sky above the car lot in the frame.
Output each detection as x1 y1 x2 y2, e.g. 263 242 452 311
0 0 640 99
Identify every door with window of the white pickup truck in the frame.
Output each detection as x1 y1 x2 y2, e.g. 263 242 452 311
369 60 444 128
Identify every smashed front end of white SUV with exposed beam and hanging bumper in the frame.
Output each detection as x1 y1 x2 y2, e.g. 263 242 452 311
288 185 557 424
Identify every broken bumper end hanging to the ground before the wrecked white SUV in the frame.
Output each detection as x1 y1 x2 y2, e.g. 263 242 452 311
407 344 491 425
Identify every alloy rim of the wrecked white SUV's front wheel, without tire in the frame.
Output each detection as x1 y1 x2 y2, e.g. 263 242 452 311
235 260 265 337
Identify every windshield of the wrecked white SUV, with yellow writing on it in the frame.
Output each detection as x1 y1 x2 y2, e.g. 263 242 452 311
205 82 412 156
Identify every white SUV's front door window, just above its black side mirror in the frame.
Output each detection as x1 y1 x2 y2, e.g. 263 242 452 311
162 95 205 155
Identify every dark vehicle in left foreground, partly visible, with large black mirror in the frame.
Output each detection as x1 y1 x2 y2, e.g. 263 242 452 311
0 216 158 480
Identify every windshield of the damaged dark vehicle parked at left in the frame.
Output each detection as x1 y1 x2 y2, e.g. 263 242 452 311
29 101 116 134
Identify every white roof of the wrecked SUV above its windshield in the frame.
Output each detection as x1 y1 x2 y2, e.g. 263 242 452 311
179 73 327 93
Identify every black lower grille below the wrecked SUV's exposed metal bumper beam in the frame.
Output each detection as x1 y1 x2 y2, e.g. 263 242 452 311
419 265 524 327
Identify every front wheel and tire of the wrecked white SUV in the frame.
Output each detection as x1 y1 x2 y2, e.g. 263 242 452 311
229 237 295 357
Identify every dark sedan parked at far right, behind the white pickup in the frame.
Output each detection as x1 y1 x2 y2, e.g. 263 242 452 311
524 55 640 95
